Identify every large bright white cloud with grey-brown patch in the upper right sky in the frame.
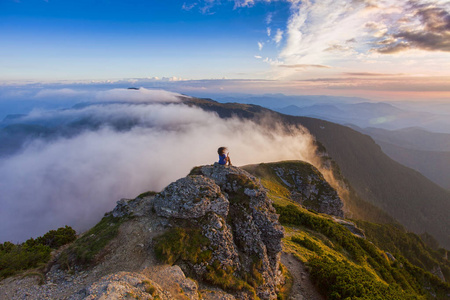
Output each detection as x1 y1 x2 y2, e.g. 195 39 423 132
255 0 450 79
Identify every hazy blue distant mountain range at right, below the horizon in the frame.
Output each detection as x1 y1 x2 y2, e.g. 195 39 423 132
217 94 450 133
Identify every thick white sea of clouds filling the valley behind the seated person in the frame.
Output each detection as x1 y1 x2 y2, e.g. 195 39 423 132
0 89 316 242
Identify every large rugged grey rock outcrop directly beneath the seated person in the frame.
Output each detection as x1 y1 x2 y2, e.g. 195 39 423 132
153 164 284 299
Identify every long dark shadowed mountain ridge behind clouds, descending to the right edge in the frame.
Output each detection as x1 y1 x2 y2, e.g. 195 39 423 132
190 99 450 248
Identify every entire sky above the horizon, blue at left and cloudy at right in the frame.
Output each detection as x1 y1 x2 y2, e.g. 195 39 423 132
0 0 450 100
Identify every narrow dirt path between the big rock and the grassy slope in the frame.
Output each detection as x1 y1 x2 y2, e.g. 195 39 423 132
281 252 326 300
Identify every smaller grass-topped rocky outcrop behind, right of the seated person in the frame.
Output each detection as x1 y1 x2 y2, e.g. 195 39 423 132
245 161 344 217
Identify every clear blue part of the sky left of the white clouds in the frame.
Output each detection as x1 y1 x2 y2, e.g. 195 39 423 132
0 0 288 80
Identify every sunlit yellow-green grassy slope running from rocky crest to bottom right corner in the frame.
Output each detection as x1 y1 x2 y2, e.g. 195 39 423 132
245 162 450 299
